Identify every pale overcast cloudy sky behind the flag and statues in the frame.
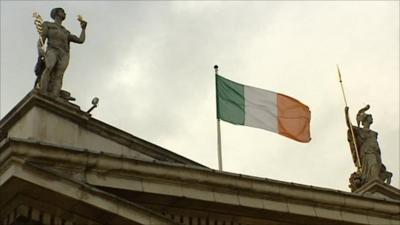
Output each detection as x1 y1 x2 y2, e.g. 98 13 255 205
0 1 400 191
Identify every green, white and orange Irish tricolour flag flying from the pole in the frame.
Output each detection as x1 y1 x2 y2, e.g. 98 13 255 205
216 75 311 142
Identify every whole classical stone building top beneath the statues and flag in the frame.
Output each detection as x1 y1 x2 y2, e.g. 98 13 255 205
0 91 400 225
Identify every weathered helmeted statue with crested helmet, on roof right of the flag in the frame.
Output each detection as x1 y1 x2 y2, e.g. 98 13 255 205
345 105 392 191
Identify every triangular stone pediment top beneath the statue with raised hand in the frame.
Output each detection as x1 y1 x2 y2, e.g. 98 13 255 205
0 90 204 167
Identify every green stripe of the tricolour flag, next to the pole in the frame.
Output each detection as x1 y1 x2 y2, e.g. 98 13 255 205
216 75 245 125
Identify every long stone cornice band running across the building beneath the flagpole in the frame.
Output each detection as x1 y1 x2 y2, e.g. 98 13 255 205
0 139 400 221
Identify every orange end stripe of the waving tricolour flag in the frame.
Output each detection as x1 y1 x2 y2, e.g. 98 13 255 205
277 94 311 142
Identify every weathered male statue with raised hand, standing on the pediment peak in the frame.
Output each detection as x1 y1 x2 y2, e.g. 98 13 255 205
35 8 87 97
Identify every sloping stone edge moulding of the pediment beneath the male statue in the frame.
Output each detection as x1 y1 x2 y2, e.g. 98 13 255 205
0 89 207 168
